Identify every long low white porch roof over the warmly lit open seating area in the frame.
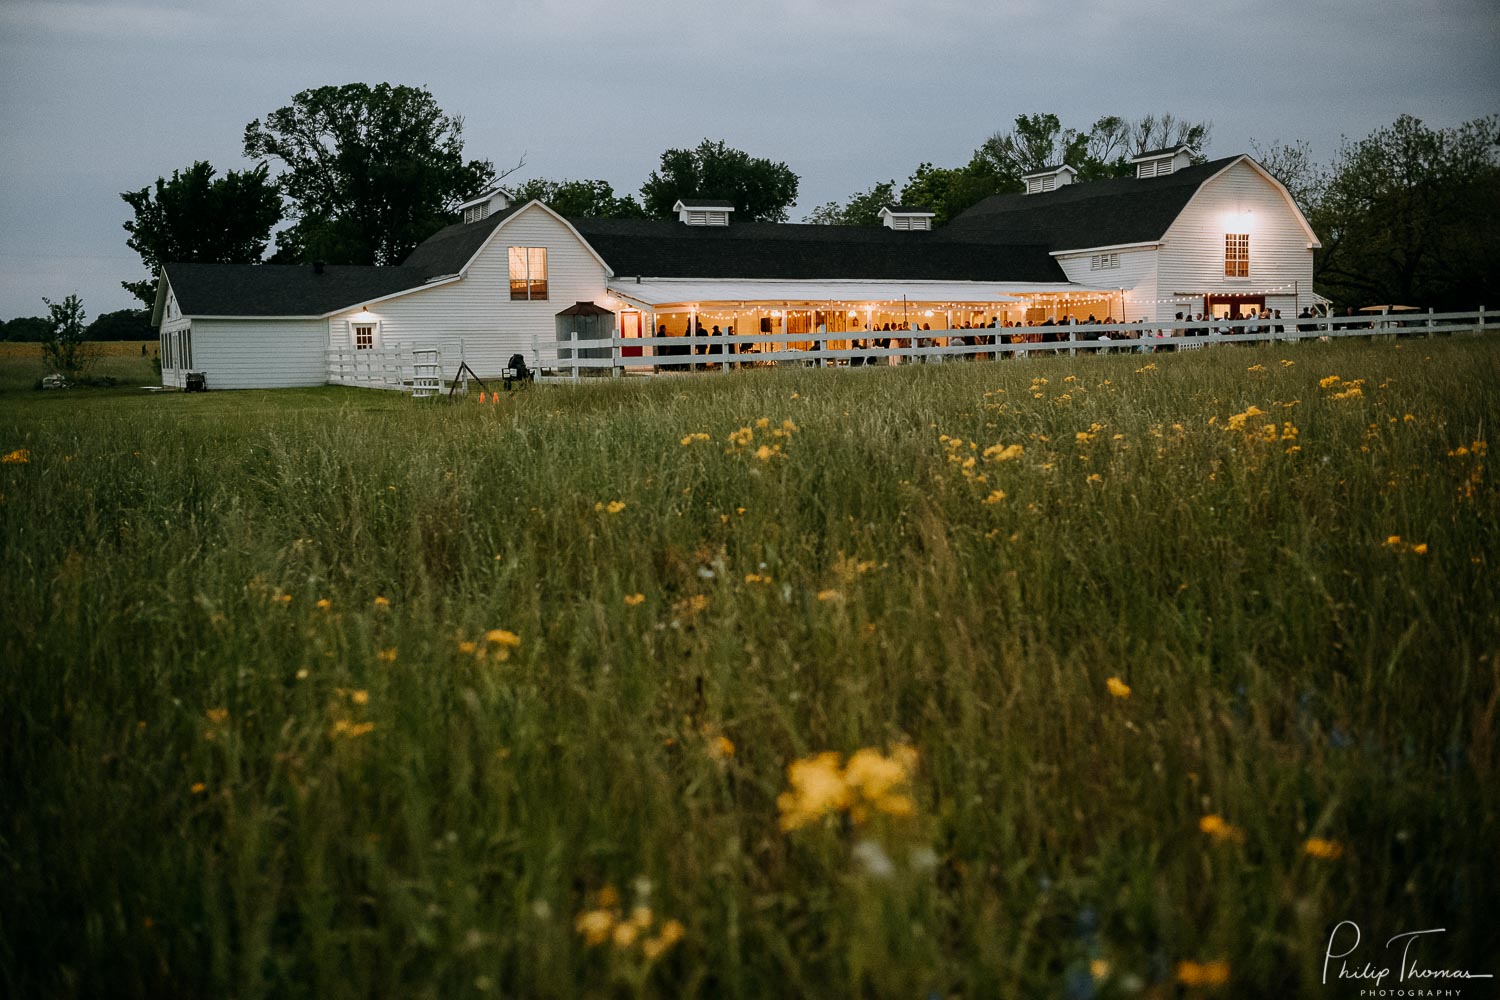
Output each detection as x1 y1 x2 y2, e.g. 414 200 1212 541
609 277 1074 310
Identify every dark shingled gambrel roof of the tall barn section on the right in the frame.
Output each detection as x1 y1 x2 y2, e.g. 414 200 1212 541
933 156 1239 250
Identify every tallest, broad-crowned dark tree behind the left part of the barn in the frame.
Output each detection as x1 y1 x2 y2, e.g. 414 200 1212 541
245 84 504 264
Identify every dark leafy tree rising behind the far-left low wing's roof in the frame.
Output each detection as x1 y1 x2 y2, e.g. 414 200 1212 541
120 160 282 306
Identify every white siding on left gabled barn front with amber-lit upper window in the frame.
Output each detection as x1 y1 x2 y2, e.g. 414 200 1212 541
329 207 606 378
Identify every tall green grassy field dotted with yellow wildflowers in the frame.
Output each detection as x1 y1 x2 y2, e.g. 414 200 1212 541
0 339 1500 999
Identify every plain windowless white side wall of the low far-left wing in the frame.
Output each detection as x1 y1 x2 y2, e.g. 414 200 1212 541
192 319 329 391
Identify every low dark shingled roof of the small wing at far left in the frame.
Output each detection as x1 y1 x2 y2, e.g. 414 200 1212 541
162 264 428 316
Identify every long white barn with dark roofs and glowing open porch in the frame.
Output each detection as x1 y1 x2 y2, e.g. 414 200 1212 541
153 148 1319 388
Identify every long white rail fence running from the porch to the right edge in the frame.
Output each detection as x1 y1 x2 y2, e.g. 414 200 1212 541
552 306 1493 379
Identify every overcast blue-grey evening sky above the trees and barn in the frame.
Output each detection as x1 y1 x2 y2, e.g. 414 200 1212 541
0 0 1500 318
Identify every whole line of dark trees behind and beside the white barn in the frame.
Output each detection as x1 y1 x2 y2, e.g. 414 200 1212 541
90 84 1500 339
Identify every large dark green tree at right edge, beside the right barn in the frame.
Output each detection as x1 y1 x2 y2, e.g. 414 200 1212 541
1310 115 1500 309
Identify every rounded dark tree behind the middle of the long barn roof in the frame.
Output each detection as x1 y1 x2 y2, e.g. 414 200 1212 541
641 139 798 222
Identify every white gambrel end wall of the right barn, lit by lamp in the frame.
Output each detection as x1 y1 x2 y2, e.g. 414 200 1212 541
1155 162 1314 318
